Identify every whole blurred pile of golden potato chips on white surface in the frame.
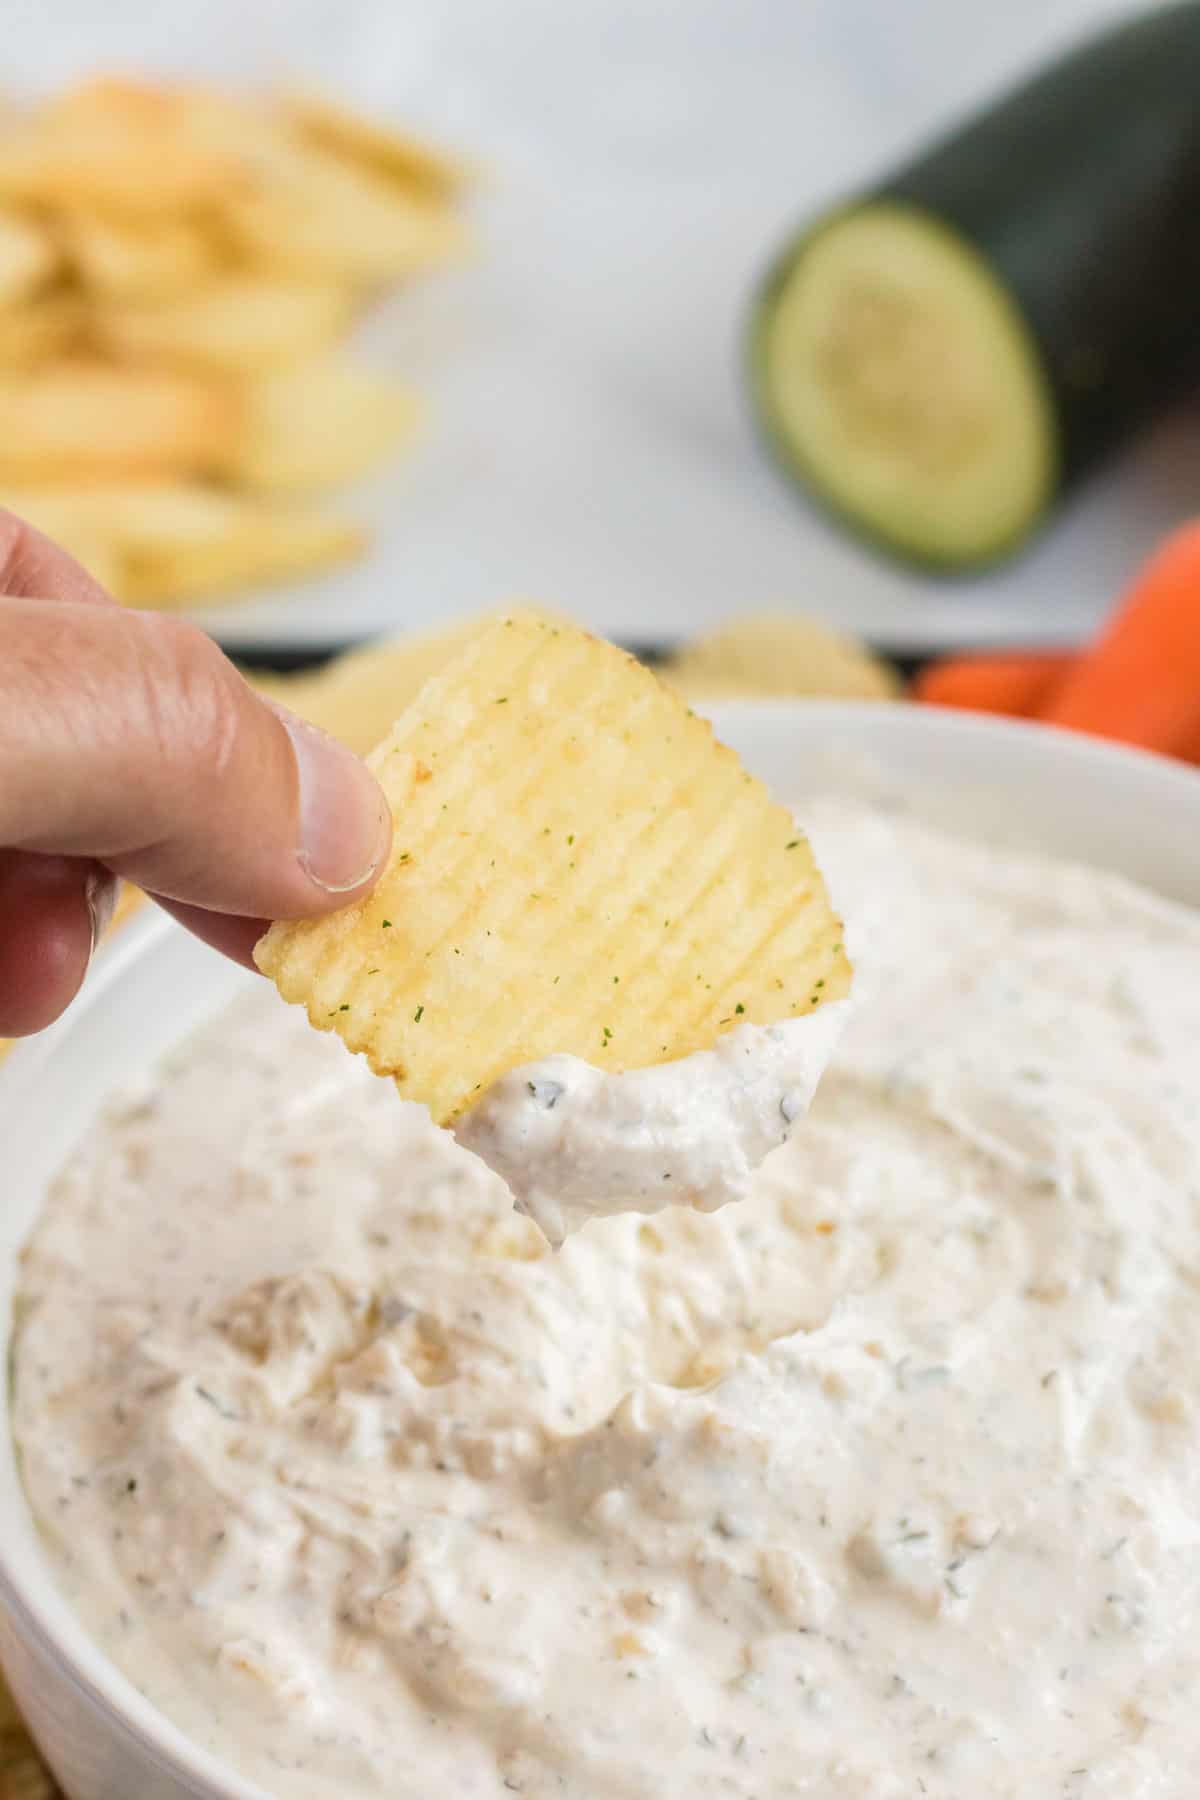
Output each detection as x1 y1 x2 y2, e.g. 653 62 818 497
0 79 466 605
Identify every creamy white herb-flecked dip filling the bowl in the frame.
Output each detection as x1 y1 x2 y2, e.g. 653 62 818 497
16 806 1200 1800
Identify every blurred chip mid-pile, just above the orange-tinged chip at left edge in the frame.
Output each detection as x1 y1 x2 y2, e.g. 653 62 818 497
94 272 353 371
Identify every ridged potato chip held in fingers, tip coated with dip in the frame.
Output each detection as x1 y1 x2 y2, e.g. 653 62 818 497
255 612 851 1238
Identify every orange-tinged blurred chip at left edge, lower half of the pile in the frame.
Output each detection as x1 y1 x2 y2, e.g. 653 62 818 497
0 360 237 482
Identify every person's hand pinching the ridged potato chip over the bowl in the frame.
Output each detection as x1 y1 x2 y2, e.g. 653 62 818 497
0 513 390 1037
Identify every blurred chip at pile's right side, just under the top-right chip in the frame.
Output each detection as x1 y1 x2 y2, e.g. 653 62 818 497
223 146 466 284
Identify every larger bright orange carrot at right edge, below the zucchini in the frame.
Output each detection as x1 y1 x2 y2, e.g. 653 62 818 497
1038 524 1200 756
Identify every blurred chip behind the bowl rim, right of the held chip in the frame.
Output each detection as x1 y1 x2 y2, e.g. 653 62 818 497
660 612 900 700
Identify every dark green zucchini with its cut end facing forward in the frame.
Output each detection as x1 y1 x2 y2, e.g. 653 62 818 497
750 0 1200 571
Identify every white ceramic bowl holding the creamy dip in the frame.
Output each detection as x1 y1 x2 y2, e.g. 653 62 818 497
0 702 1200 1800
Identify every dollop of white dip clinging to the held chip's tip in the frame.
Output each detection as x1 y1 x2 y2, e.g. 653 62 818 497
455 1001 847 1244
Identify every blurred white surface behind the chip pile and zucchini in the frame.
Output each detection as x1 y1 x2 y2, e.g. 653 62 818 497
5 0 1200 646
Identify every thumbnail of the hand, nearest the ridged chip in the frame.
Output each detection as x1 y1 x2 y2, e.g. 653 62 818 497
281 713 389 895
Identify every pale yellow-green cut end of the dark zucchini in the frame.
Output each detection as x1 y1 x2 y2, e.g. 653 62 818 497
752 202 1058 569
